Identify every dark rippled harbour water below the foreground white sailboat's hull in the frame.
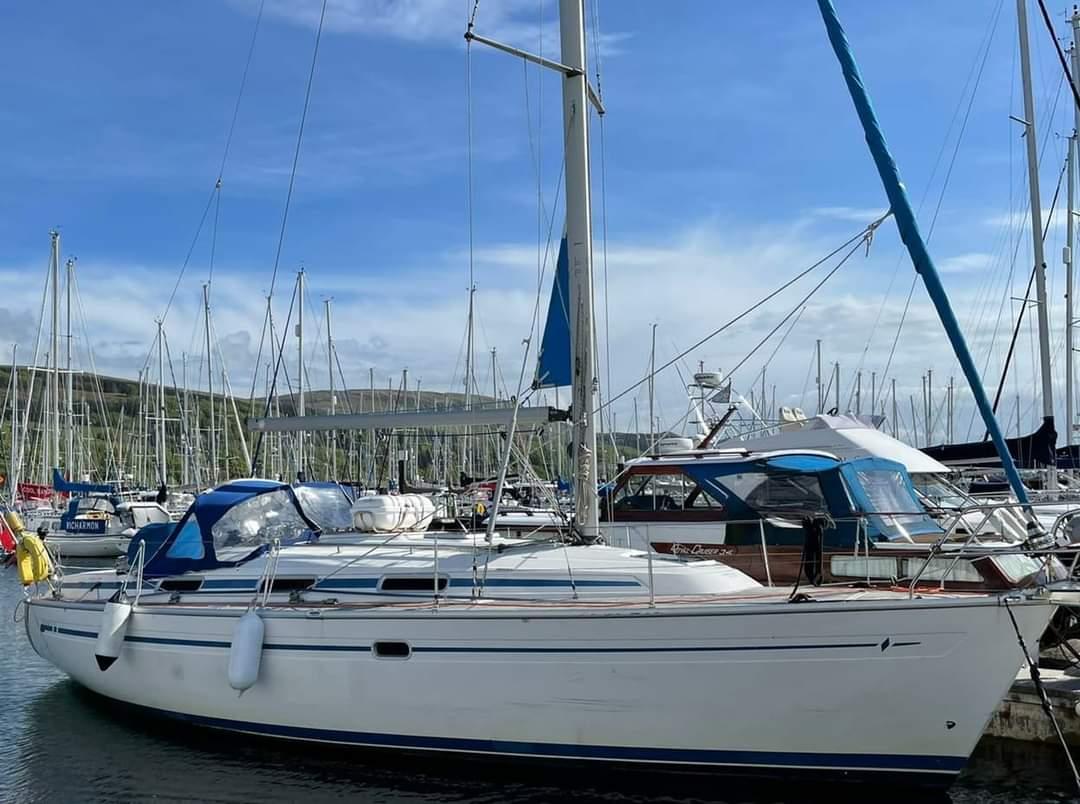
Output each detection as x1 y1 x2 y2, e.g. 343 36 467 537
0 570 1080 804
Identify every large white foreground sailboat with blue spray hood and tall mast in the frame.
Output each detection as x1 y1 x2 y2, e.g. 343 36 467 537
25 0 1067 785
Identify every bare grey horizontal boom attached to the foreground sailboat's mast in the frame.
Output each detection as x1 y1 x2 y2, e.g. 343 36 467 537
247 405 569 432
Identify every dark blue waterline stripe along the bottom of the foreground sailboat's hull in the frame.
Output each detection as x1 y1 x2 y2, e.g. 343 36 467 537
126 707 968 775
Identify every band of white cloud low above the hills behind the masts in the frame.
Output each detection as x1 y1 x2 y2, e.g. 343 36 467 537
0 210 1071 451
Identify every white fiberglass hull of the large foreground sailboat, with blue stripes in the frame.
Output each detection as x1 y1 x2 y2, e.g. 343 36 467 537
26 595 1052 785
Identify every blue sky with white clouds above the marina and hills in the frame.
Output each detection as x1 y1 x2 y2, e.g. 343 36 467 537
0 0 1071 443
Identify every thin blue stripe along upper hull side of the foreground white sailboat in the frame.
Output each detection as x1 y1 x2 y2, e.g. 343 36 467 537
35 624 920 655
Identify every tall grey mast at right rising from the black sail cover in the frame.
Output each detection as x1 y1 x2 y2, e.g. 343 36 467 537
1016 0 1057 488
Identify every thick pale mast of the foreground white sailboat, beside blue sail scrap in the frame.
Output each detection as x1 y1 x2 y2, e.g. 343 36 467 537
558 0 599 540
